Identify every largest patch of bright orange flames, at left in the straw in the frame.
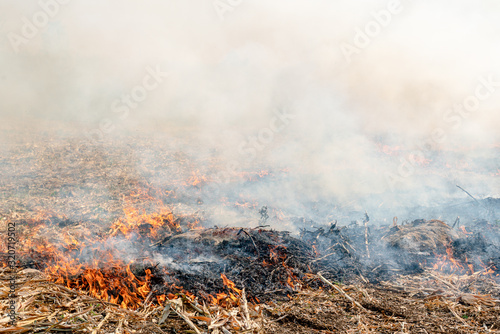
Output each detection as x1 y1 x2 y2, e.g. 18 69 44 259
3 191 203 309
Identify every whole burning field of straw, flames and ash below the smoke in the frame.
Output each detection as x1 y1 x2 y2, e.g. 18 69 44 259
0 133 500 334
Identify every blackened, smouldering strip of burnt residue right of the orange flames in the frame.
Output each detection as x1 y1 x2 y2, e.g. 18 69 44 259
14 216 500 301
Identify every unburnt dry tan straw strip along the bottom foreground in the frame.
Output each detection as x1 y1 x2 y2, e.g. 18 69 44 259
0 269 500 334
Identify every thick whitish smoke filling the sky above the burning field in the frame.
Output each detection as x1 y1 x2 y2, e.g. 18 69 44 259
0 0 500 227
